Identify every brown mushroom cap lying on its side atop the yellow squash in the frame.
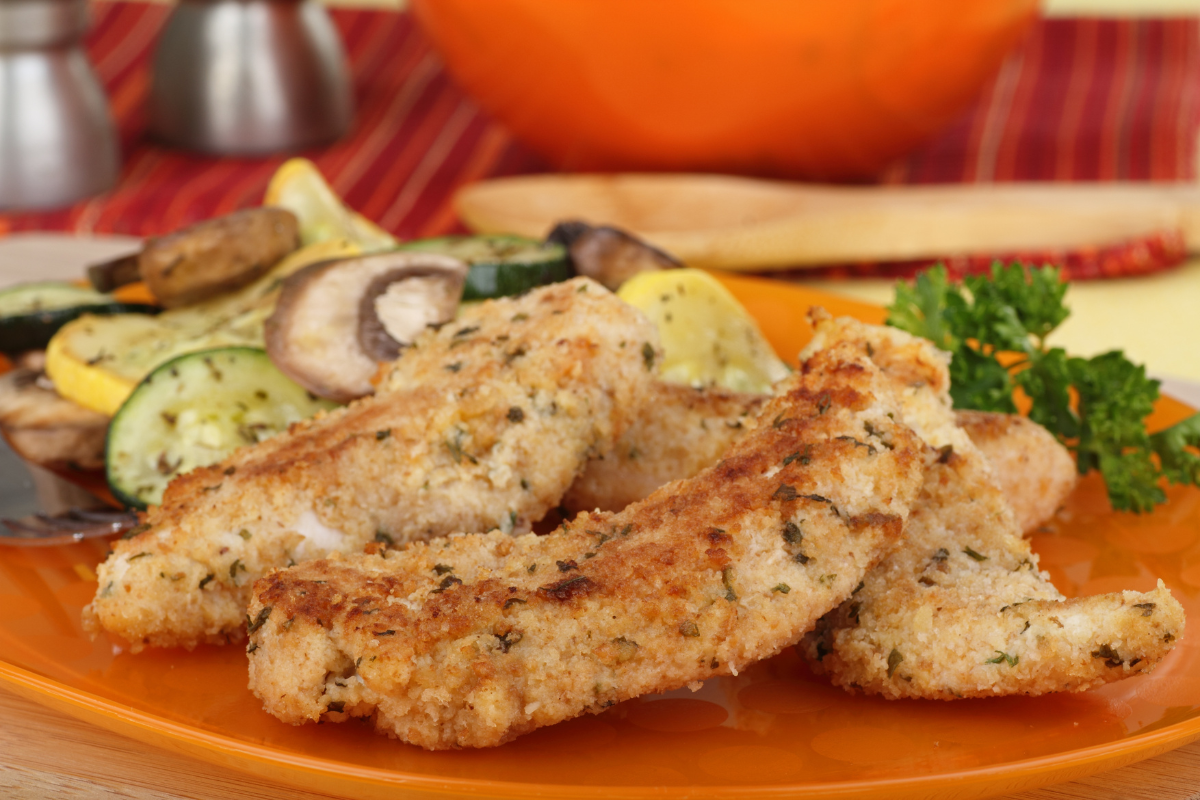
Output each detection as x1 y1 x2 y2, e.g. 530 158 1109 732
138 207 300 308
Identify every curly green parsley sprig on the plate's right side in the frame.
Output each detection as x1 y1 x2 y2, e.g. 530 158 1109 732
888 264 1200 512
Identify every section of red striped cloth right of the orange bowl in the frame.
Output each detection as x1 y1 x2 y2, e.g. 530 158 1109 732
882 18 1200 184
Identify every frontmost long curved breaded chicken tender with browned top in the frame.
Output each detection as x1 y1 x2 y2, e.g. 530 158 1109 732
247 335 935 750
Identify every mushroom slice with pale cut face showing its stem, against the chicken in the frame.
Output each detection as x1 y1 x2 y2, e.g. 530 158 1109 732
265 251 468 403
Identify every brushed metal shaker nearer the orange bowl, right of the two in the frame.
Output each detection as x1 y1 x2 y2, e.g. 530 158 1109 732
148 0 354 155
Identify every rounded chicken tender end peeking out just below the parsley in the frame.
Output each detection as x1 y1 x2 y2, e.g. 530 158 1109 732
954 410 1079 534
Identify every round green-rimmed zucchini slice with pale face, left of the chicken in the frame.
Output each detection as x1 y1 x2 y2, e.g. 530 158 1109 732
104 347 334 509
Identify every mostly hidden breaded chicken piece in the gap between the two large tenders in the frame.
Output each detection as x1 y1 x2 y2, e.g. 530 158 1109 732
563 381 767 511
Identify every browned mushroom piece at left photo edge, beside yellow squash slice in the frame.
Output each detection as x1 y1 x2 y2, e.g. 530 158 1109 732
0 367 108 469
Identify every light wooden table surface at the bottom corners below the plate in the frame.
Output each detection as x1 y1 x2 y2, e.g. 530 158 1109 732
0 690 1200 800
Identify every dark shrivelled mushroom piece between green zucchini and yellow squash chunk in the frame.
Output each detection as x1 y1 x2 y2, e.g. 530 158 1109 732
546 219 683 291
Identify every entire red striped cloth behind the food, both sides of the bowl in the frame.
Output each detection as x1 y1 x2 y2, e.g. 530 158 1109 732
0 2 1200 280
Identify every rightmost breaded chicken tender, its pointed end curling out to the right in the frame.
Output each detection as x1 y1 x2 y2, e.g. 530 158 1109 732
800 319 1183 699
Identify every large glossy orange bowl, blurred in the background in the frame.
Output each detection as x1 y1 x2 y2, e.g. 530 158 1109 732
412 0 1038 179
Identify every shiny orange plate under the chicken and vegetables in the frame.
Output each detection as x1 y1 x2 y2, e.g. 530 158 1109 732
0 278 1200 798
